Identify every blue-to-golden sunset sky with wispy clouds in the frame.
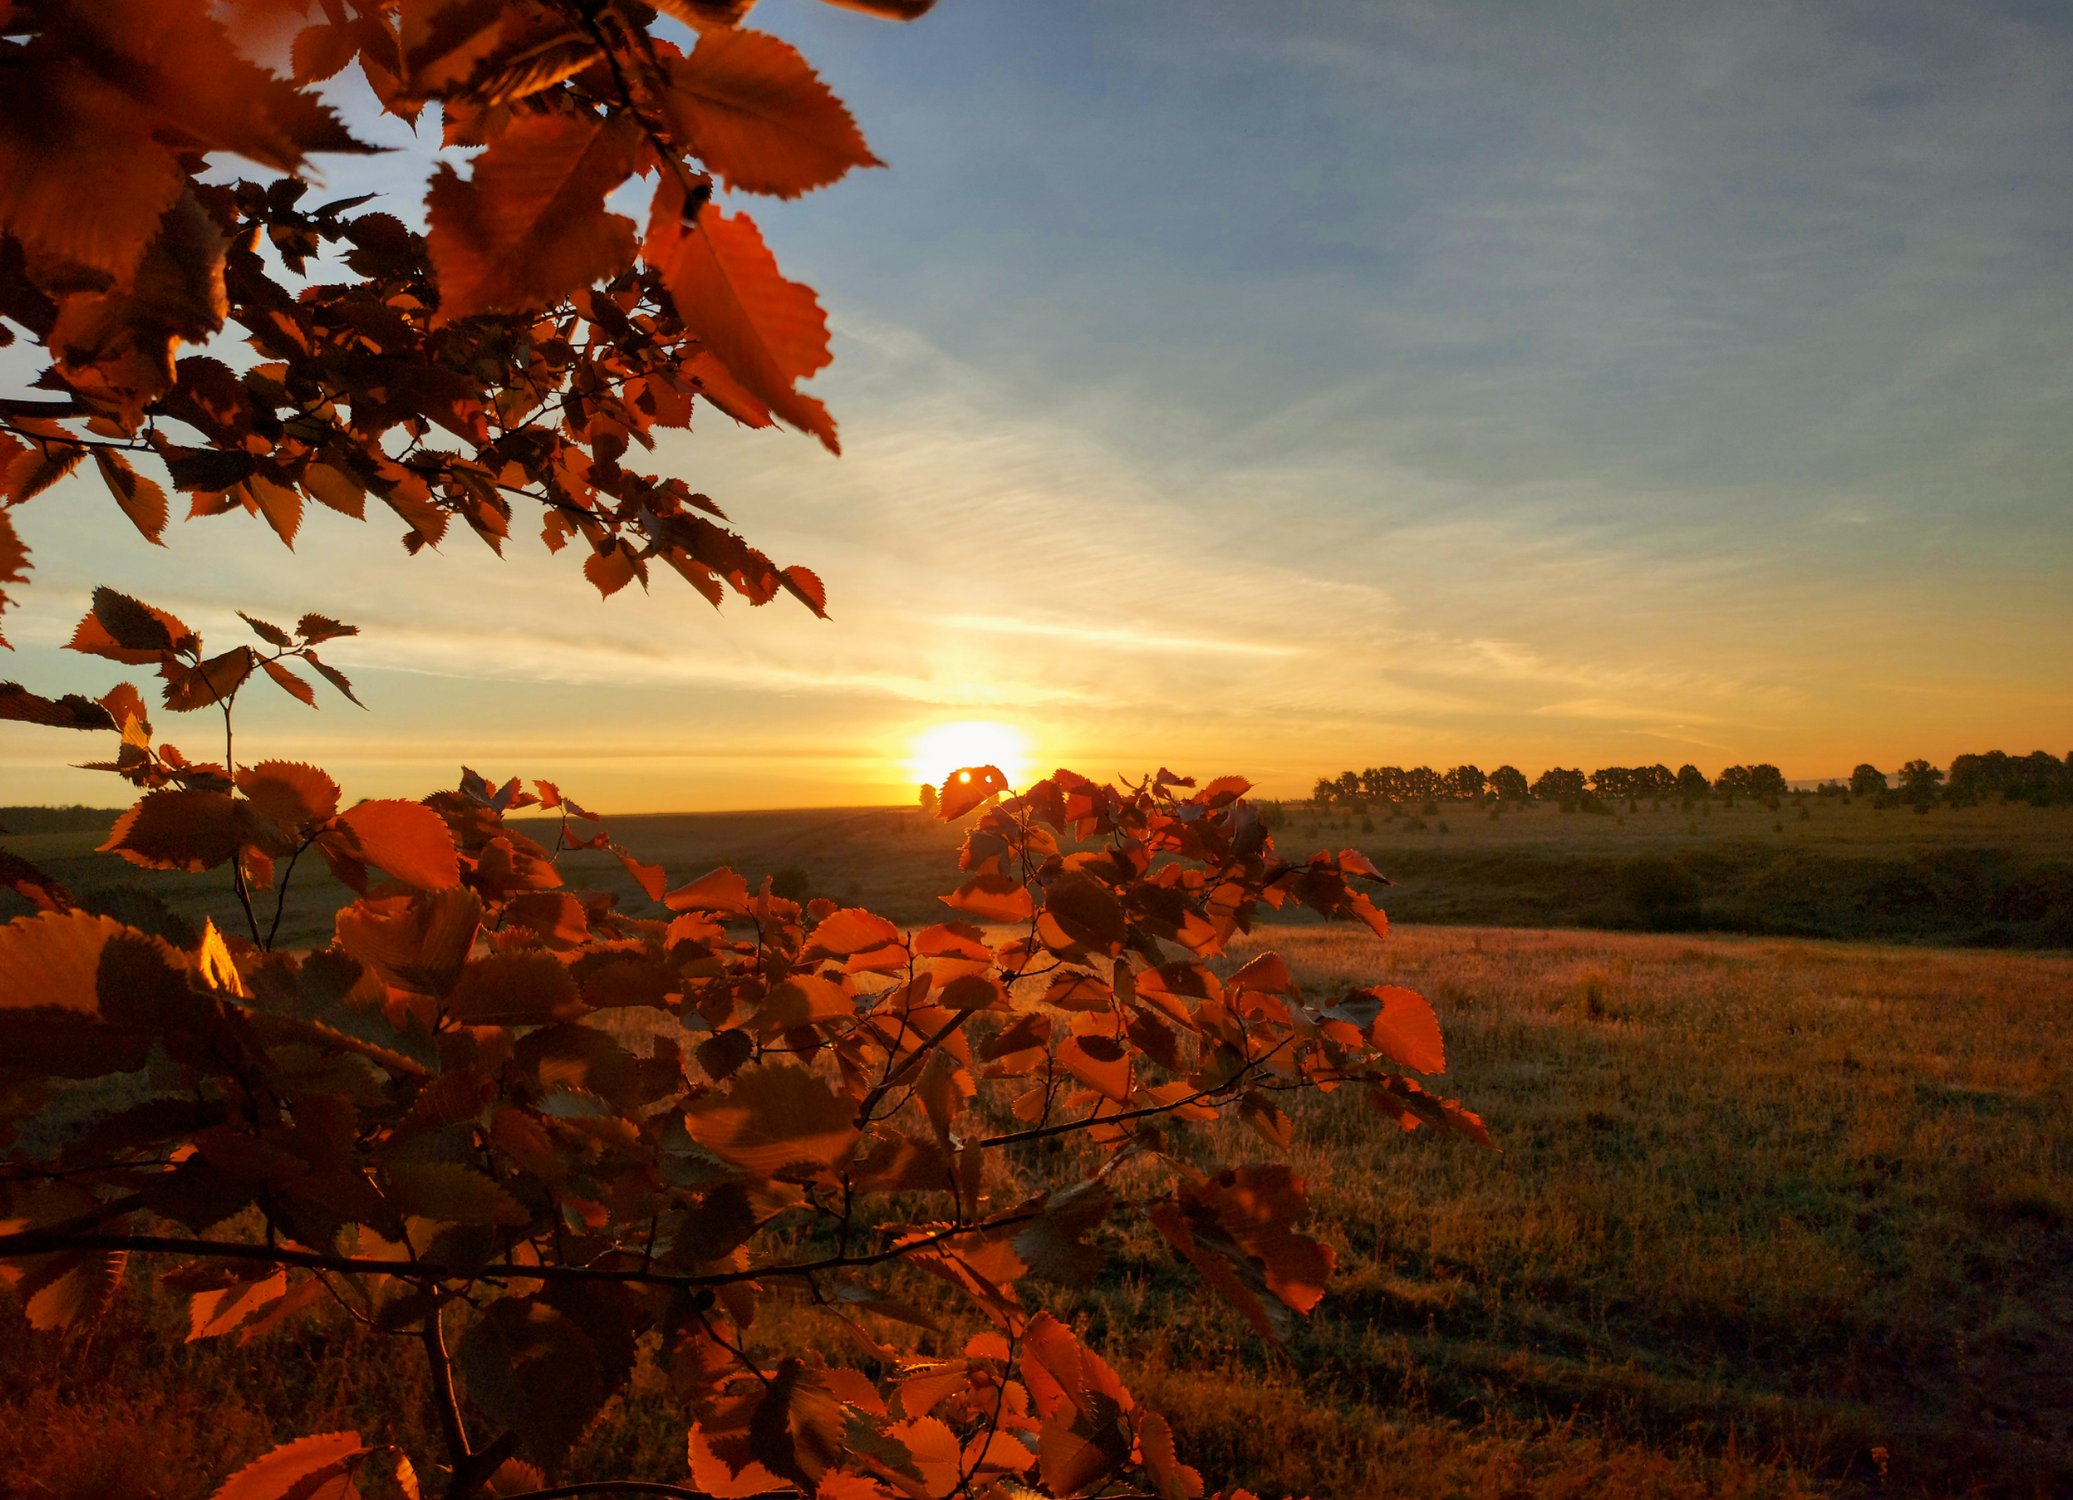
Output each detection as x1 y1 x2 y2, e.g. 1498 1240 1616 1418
0 0 2073 812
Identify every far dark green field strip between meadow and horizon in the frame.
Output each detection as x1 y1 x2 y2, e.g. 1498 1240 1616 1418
0 796 2073 947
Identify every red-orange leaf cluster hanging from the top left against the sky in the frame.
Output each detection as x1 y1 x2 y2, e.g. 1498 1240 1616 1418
0 0 891 638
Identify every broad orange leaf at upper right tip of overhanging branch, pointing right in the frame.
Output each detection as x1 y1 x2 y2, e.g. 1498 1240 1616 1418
663 29 883 199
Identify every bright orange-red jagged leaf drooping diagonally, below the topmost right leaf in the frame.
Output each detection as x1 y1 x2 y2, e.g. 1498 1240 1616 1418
641 193 840 452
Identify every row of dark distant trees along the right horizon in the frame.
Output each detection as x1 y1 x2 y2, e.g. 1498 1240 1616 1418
1310 750 2073 808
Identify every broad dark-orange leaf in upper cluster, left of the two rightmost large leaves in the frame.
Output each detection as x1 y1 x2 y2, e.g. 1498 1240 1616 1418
425 114 636 325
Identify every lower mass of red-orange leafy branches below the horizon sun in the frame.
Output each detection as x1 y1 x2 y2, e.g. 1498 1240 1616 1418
0 590 1486 1500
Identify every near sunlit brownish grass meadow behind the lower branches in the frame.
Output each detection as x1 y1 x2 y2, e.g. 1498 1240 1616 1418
0 919 2073 1500
